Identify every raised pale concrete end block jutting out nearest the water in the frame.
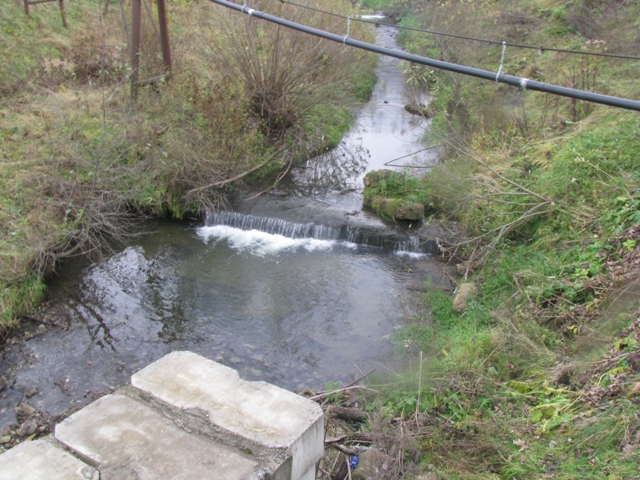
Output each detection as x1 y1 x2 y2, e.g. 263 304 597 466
131 352 324 480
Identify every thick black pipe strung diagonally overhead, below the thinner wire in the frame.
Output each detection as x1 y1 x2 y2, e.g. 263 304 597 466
210 0 640 111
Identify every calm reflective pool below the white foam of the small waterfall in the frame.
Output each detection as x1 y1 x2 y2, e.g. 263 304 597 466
0 219 440 430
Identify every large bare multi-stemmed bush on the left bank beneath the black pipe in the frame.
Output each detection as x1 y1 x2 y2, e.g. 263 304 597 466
200 1 370 138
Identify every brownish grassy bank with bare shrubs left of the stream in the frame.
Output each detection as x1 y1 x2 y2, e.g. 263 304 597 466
0 0 375 330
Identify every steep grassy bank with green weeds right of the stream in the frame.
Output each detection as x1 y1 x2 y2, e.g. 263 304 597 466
348 0 640 479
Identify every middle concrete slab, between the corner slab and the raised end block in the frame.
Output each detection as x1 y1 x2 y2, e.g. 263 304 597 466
55 394 263 480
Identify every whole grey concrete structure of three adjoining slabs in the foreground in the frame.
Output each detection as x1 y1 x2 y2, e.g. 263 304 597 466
0 351 324 480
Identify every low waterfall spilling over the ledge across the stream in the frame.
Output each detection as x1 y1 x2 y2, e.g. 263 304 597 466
205 211 434 254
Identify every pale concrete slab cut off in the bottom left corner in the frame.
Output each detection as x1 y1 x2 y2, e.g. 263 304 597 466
0 440 100 480
